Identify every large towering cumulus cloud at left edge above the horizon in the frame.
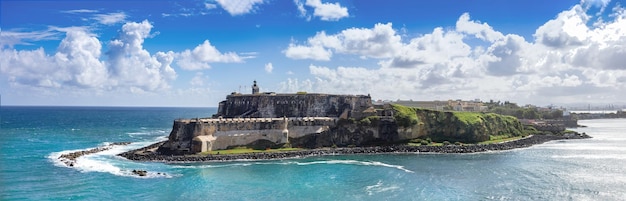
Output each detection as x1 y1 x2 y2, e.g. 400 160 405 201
0 21 176 92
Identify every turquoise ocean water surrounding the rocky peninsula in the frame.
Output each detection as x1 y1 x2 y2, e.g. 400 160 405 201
0 106 626 200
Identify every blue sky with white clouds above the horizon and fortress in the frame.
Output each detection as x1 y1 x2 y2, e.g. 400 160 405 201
0 0 626 107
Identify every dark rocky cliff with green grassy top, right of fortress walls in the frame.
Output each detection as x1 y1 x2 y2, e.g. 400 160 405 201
290 105 524 148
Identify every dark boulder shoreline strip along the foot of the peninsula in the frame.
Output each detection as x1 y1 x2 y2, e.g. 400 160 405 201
119 133 590 163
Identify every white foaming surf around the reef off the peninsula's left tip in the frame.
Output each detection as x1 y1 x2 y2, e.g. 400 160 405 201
47 136 174 178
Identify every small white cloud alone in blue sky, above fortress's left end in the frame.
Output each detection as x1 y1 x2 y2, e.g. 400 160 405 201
177 40 244 70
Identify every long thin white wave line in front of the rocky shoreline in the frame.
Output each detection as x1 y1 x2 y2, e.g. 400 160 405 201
172 160 414 173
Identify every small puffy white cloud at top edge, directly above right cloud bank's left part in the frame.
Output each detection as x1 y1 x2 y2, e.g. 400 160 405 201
296 0 348 21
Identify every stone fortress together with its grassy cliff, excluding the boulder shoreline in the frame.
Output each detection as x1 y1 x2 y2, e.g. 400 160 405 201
156 82 524 155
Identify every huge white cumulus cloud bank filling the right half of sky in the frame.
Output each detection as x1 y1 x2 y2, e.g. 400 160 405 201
283 1 626 103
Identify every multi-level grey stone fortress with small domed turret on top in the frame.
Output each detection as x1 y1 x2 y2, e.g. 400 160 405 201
159 81 376 153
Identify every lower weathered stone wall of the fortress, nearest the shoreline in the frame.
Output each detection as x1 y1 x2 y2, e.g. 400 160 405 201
160 117 337 153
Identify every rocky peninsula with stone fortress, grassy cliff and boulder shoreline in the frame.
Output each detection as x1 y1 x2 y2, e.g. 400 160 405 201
120 81 588 161
